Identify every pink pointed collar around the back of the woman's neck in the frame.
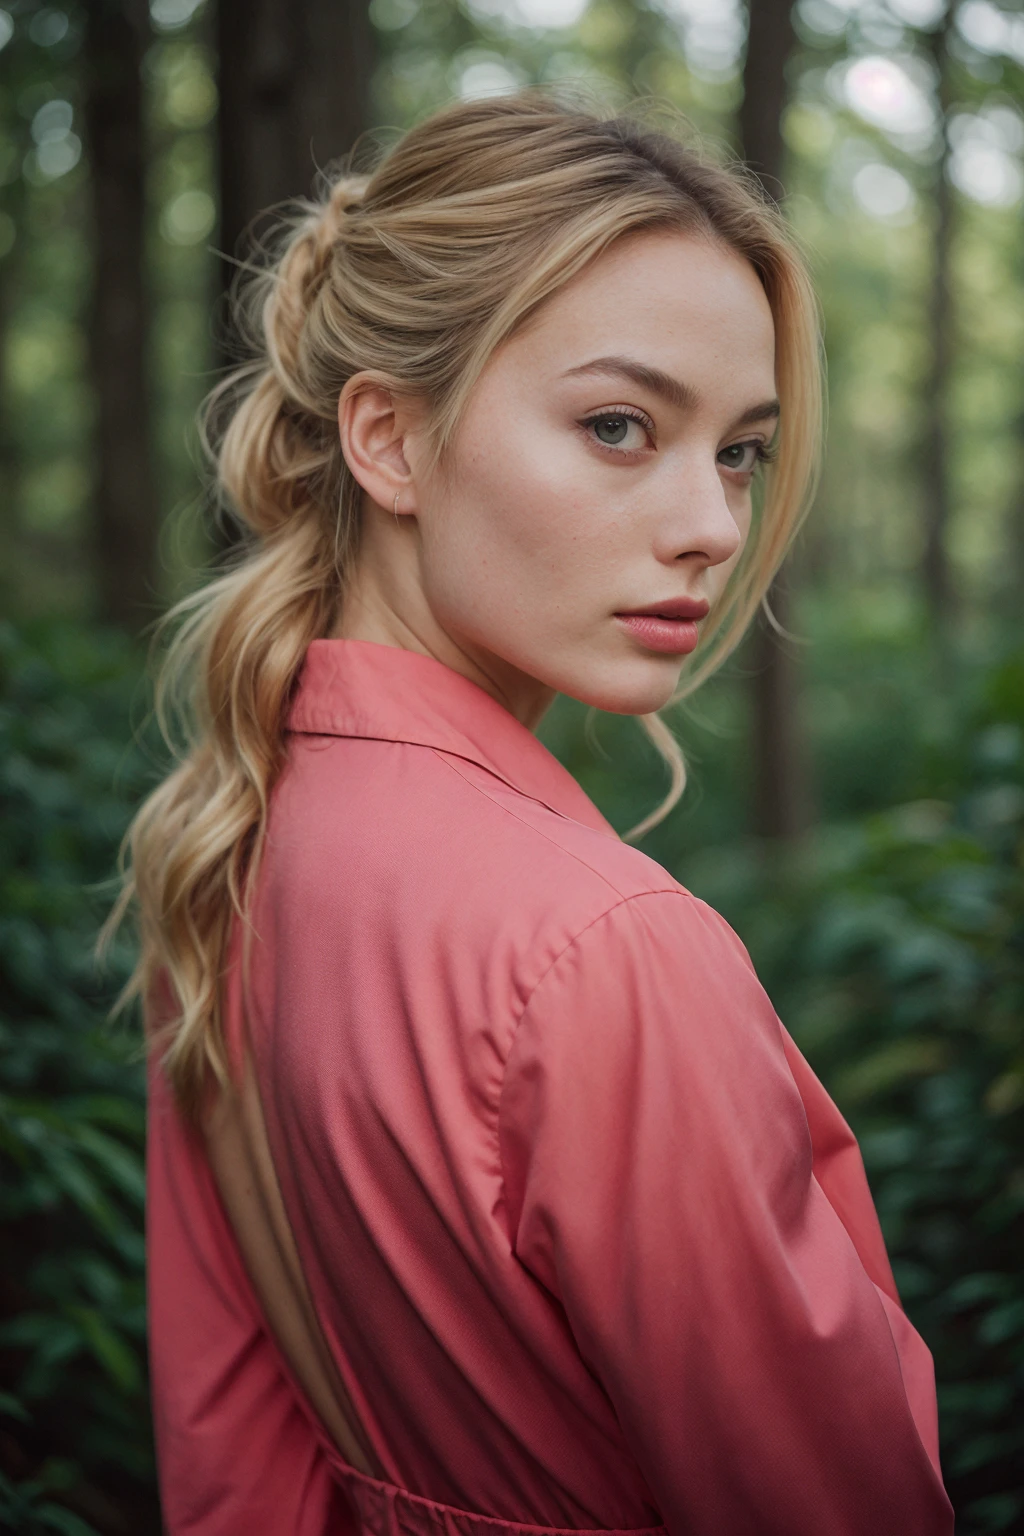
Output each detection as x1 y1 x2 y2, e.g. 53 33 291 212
287 639 617 837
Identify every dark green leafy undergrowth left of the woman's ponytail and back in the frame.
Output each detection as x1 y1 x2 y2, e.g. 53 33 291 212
0 625 158 1536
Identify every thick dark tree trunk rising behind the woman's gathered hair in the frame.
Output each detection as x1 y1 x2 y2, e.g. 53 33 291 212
216 0 373 307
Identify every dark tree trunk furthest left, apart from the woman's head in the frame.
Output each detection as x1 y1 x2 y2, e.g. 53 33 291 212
84 0 158 628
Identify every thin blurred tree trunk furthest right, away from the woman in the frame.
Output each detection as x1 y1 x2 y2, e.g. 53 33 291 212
921 5 955 644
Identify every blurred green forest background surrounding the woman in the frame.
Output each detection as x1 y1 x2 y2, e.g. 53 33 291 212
0 0 1024 1536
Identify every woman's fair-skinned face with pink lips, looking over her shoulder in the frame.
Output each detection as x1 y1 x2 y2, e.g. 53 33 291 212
342 232 778 723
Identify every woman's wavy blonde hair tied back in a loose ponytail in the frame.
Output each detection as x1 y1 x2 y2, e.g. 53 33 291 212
101 91 821 1114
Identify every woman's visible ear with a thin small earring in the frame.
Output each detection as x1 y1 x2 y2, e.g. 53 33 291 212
338 373 422 515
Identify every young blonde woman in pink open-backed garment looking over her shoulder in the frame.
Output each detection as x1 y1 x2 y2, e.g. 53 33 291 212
115 94 952 1536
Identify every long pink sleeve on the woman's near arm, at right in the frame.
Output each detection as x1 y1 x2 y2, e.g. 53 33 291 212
499 891 953 1536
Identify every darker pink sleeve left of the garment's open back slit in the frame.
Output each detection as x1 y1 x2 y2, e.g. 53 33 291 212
146 1057 343 1536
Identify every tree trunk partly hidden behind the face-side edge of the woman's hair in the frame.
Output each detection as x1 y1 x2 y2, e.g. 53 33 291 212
740 0 812 842
